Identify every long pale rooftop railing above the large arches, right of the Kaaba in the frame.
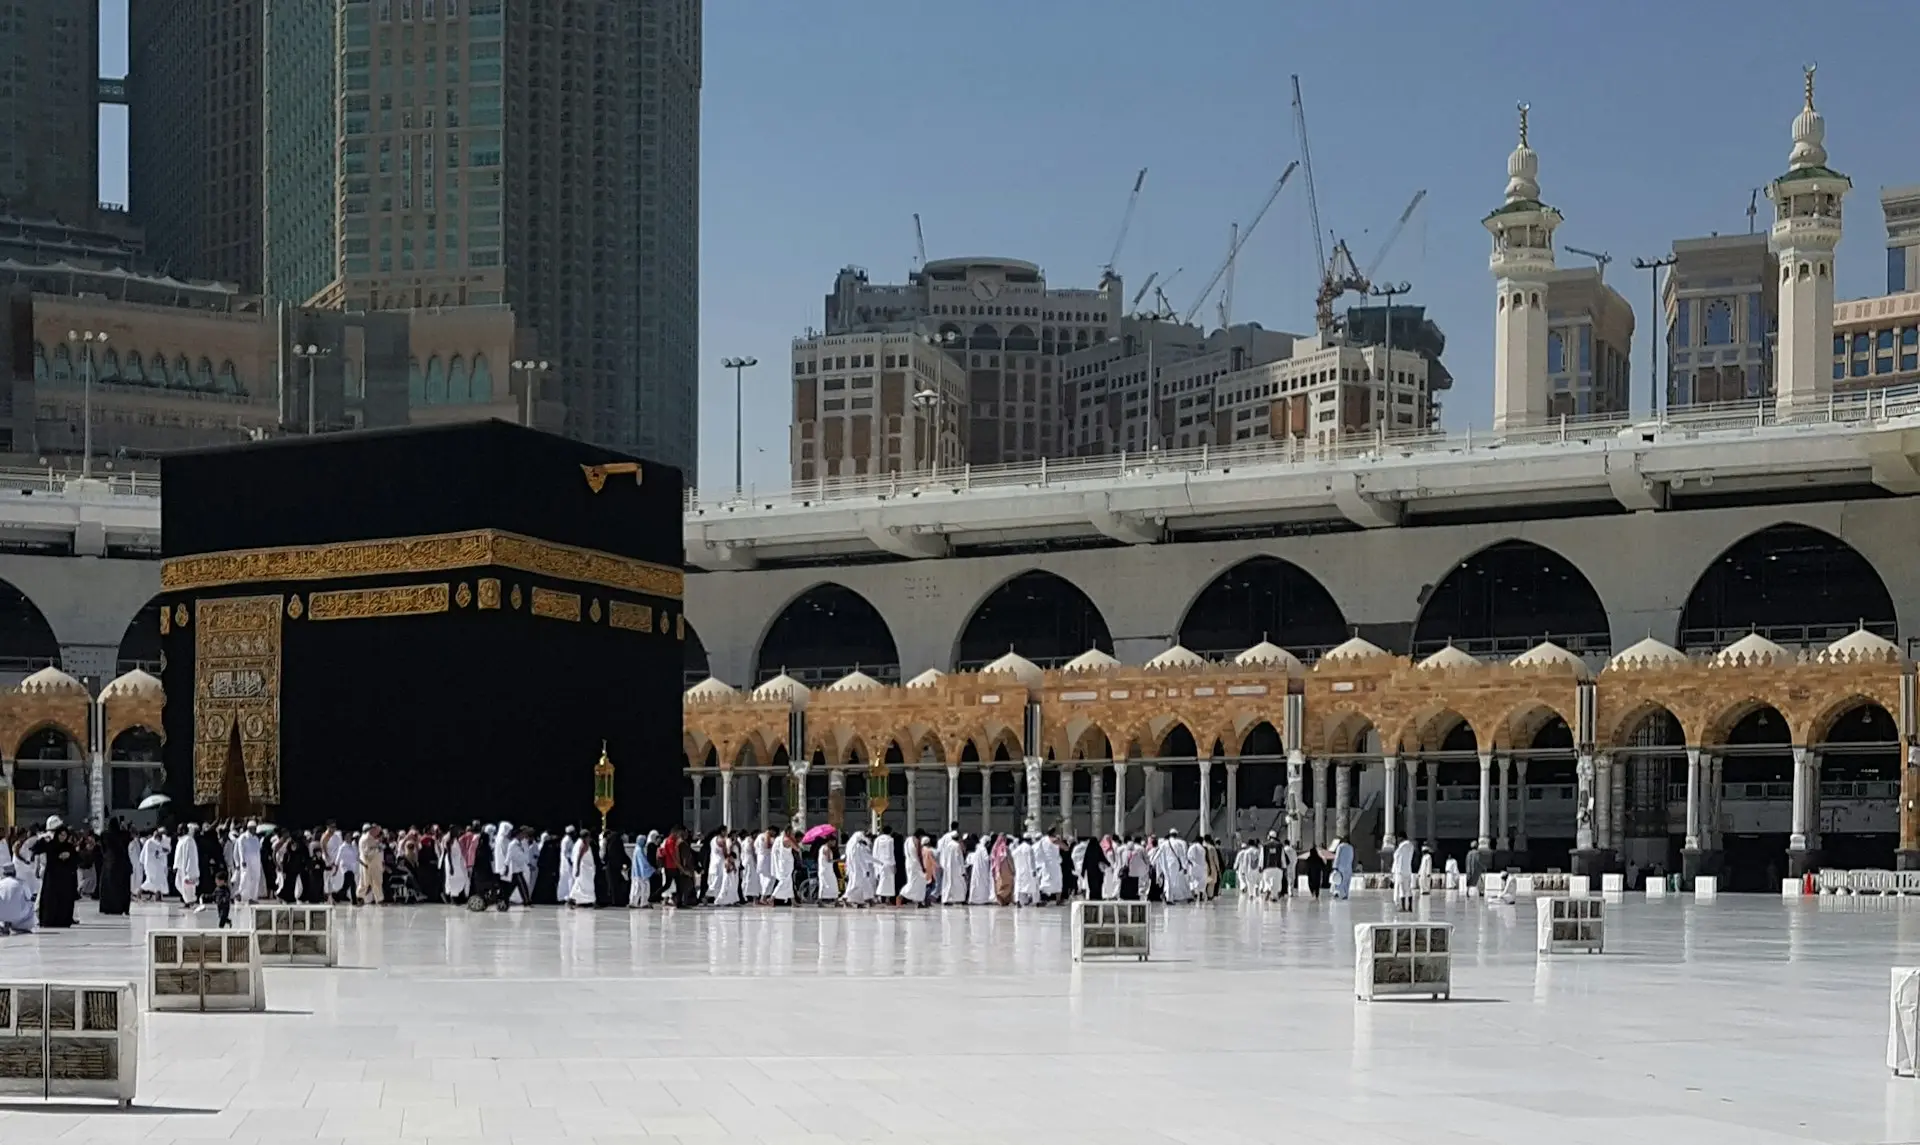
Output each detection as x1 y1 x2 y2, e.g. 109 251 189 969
685 382 1920 515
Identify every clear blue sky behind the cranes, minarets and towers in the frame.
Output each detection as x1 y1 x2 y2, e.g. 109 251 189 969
102 0 1920 484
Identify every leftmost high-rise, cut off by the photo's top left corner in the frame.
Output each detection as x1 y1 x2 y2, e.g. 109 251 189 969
0 0 100 227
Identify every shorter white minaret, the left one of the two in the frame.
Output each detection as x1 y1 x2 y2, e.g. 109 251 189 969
1482 104 1561 430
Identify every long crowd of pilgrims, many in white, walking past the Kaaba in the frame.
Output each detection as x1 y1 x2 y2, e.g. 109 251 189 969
0 818 1390 932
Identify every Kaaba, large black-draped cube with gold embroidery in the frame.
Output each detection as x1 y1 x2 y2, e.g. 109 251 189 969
159 421 685 828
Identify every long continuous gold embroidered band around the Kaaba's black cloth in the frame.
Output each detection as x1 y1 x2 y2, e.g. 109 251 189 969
159 528 685 599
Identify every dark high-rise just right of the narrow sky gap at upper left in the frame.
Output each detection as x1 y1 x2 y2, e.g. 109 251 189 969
127 0 264 294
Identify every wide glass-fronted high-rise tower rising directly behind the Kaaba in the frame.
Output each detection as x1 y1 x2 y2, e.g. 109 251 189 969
332 0 701 473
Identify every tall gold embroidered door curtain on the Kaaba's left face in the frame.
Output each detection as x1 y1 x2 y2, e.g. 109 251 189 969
194 596 282 805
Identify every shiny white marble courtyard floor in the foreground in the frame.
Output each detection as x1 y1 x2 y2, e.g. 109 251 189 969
0 895 1920 1145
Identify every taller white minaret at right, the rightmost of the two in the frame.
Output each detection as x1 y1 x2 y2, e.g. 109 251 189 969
1766 67 1853 409
